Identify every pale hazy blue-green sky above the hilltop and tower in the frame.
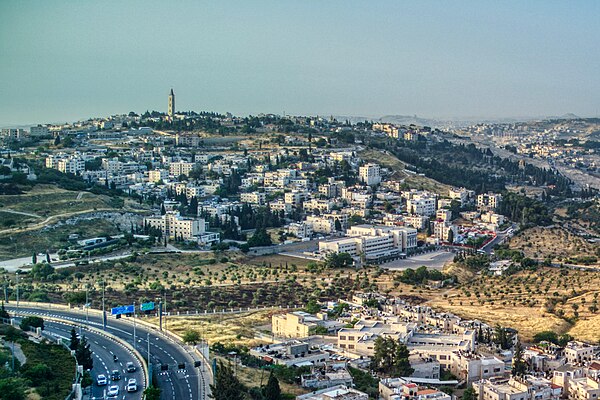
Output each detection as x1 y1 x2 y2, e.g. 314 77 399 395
0 0 600 125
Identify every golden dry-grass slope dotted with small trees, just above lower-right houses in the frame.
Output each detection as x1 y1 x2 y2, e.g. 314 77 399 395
427 268 600 340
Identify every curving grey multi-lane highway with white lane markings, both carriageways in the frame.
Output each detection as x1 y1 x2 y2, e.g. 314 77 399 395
6 303 208 400
